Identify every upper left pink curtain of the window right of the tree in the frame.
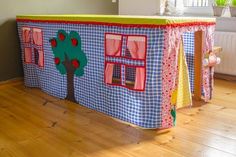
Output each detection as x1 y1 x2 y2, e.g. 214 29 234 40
106 36 121 56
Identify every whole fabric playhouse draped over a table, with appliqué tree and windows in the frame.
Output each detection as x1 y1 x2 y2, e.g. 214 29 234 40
17 15 215 129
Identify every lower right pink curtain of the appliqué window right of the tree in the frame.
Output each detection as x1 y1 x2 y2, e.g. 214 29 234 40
134 68 145 90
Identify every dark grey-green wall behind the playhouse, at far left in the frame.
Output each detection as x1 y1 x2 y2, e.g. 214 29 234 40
0 0 118 81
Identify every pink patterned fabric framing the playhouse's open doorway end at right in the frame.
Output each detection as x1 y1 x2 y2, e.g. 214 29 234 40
161 25 215 128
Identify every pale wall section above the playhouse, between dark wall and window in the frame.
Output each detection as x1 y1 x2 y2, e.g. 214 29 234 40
119 0 162 15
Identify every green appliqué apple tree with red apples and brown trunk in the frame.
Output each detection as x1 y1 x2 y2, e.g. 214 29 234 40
50 30 87 101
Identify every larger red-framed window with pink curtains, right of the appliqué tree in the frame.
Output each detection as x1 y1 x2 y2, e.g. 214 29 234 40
104 33 147 91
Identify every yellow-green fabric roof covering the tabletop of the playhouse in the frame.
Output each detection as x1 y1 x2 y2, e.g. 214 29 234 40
16 15 215 25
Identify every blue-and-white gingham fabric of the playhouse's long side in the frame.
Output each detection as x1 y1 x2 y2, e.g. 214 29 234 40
18 22 195 128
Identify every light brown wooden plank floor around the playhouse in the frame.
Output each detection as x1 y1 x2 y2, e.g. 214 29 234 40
0 80 236 157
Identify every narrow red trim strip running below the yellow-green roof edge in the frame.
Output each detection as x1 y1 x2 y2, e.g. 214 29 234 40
16 19 216 28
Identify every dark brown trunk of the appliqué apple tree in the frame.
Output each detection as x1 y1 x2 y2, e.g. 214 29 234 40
63 55 76 102
